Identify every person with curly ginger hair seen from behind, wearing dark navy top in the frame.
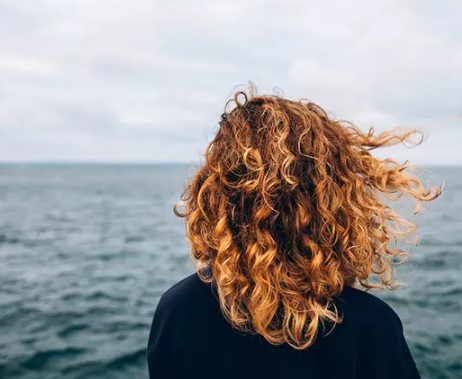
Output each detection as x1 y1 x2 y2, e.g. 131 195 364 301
147 87 441 379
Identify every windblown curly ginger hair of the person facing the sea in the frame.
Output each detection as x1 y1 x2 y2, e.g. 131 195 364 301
174 86 441 349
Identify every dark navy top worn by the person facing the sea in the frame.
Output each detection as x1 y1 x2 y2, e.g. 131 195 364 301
147 273 420 379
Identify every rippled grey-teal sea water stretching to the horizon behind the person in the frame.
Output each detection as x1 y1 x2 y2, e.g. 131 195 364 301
0 164 462 379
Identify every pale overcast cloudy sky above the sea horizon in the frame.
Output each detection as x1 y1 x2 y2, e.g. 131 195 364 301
0 0 462 165
